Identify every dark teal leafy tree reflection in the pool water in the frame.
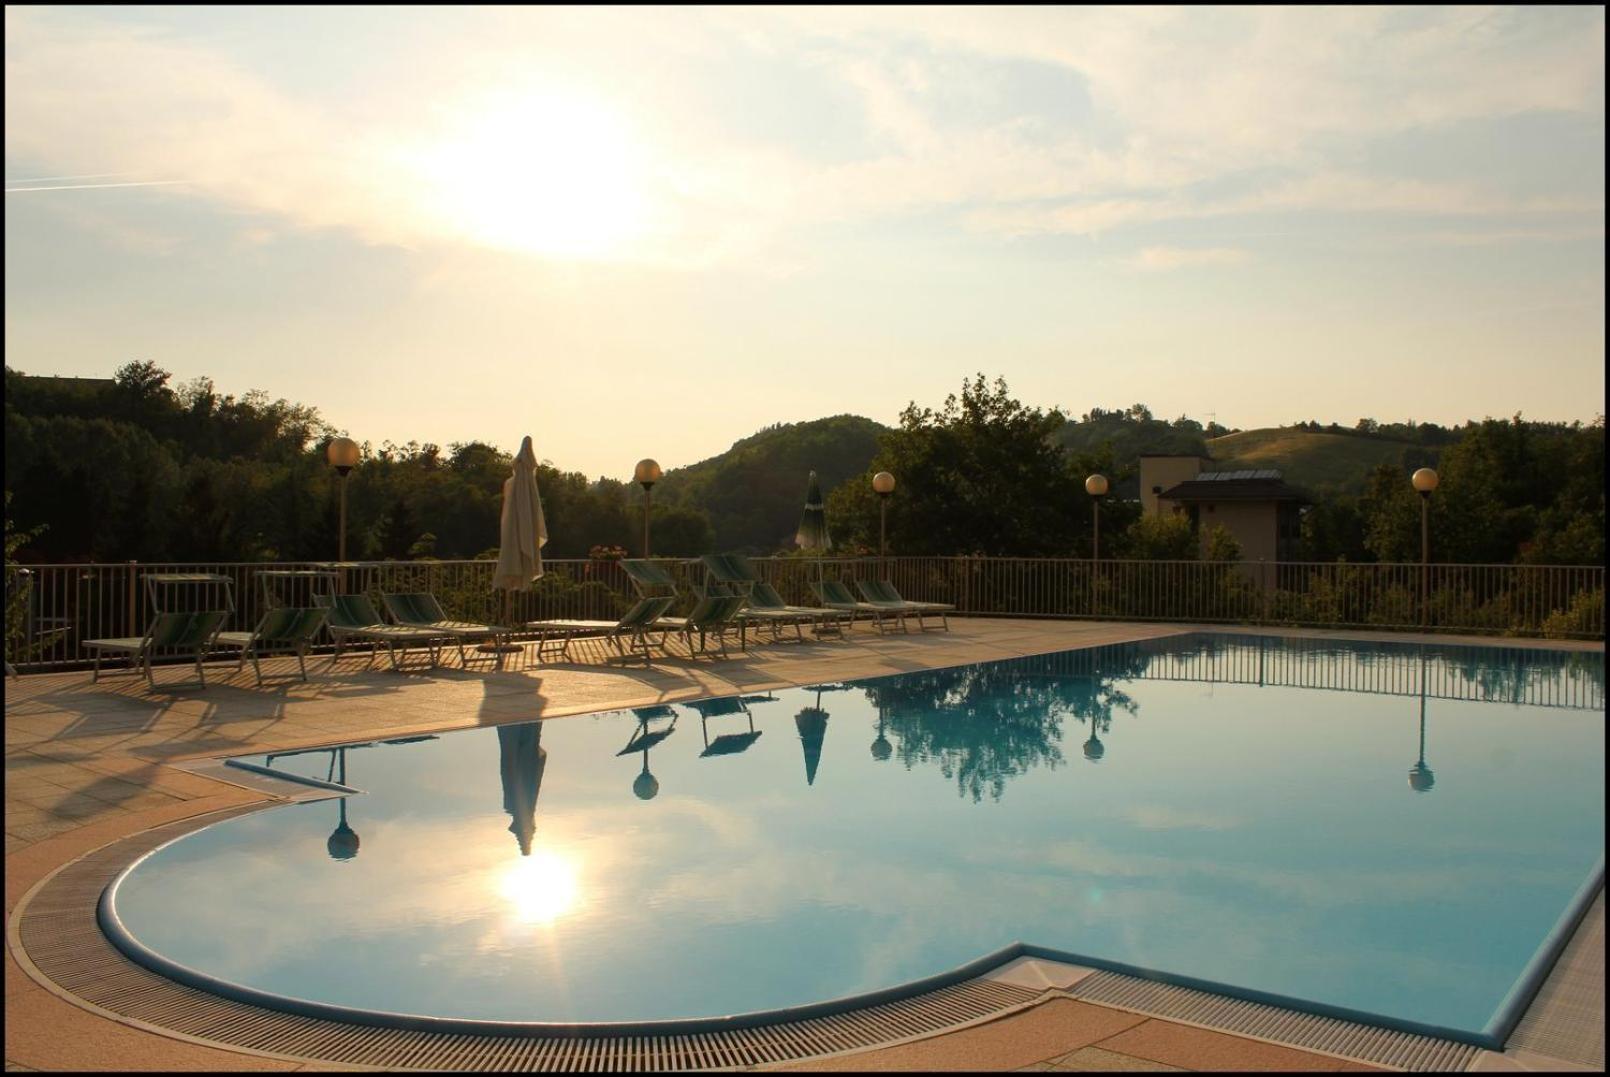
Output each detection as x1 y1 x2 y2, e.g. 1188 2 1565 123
861 644 1146 802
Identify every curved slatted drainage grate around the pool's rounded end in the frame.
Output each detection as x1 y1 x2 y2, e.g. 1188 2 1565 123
14 805 1040 1071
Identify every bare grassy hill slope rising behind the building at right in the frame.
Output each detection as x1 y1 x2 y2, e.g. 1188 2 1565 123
1208 427 1436 494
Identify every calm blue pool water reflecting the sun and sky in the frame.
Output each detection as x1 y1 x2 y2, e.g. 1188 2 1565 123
114 634 1605 1034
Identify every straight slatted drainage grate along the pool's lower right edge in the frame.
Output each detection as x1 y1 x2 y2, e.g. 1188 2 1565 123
1067 972 1481 1071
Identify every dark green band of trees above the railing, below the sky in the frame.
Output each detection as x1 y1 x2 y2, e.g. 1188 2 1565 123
5 362 1605 563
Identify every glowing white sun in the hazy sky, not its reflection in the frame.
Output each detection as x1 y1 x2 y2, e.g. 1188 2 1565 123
415 89 647 258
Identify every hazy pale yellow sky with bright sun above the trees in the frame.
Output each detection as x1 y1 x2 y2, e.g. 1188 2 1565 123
5 6 1605 478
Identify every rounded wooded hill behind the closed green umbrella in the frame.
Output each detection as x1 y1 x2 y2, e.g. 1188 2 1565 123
654 415 889 552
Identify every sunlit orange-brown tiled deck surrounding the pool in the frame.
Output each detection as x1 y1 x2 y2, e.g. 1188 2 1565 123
5 618 1604 1071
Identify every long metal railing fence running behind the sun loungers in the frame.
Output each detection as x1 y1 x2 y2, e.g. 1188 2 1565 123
6 557 1605 670
